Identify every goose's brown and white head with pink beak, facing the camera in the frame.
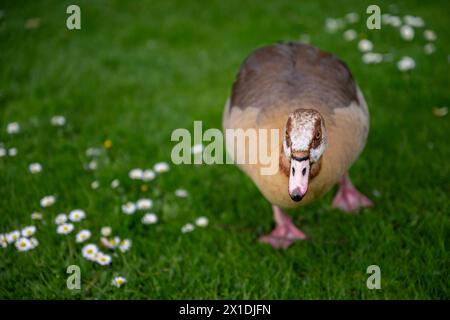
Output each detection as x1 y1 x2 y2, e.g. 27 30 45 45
283 109 327 202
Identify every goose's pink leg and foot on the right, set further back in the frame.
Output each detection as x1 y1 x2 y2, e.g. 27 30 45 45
333 173 373 212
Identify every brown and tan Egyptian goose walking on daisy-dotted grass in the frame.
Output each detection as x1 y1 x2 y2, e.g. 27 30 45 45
223 43 372 248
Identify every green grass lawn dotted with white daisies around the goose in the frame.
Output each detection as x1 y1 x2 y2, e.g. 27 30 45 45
0 0 450 299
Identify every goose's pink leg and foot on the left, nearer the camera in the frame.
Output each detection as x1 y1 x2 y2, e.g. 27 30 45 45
259 206 306 249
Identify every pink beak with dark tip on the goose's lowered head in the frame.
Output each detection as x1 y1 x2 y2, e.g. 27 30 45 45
288 157 310 202
